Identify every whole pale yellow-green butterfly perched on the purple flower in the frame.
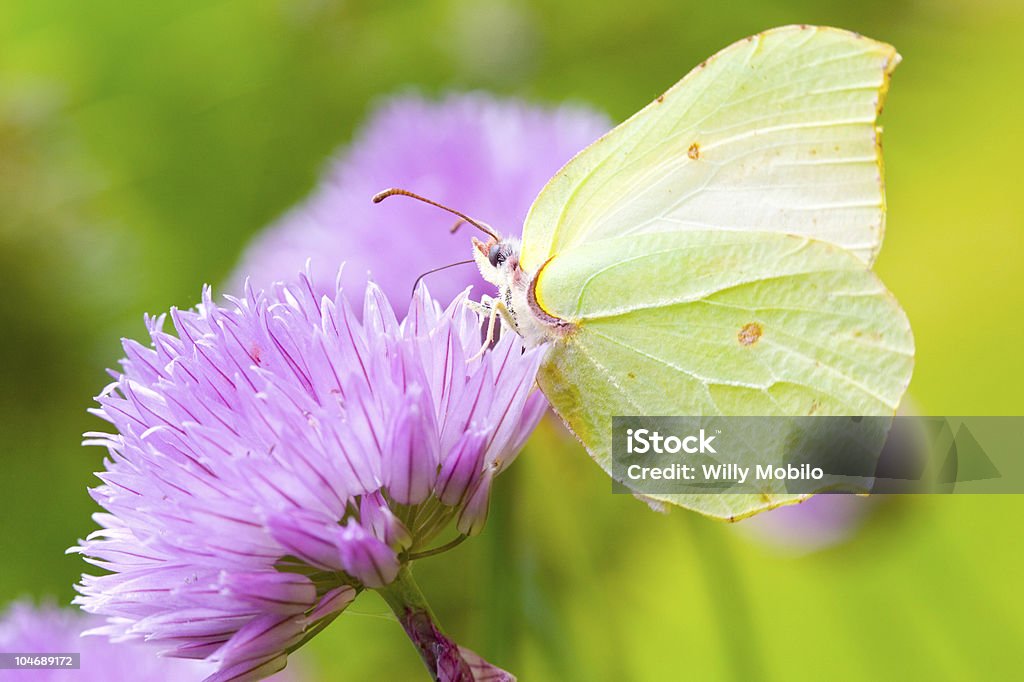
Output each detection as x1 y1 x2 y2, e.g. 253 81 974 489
378 26 913 519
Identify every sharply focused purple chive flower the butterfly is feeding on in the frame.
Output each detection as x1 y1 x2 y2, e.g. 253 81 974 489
71 272 546 681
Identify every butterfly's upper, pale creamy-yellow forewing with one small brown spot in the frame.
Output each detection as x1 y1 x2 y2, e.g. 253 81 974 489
521 27 899 272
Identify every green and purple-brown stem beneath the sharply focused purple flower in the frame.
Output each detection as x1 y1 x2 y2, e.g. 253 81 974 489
377 563 473 682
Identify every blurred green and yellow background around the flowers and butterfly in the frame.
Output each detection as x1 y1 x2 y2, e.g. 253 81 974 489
0 0 1024 680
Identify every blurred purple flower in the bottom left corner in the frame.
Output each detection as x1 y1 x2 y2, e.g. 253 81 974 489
0 602 222 682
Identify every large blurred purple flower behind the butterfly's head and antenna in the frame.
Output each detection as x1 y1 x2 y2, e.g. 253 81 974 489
233 93 610 301
